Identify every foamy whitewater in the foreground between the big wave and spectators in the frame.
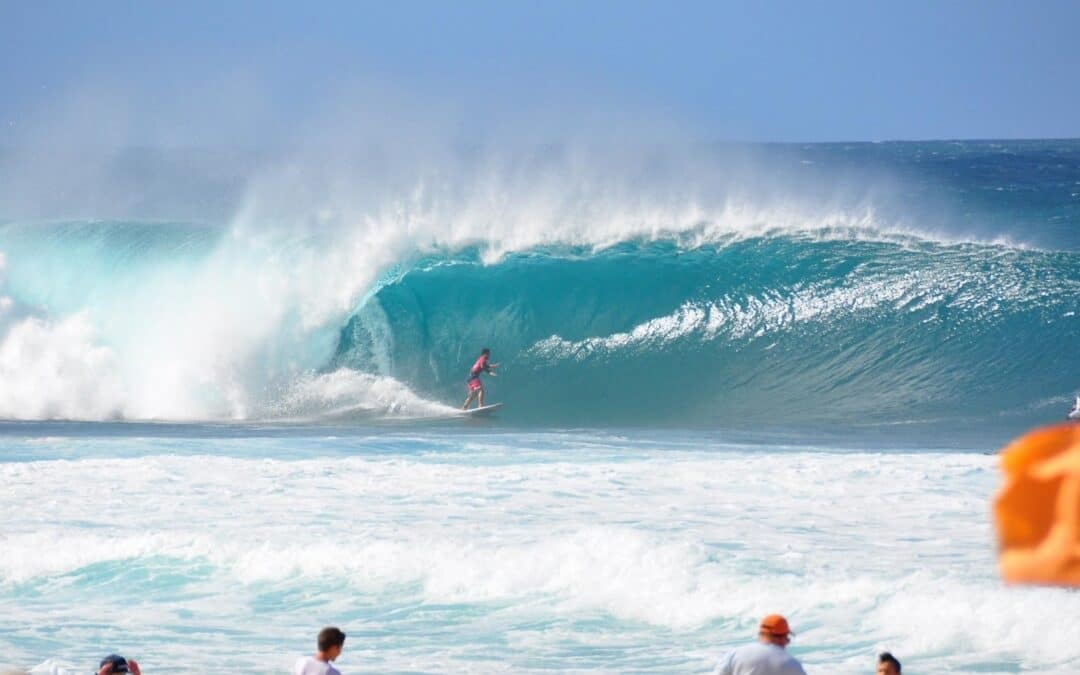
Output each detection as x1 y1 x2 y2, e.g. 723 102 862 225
0 432 1080 673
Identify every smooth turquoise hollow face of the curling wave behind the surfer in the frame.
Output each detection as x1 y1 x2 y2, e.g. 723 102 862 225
333 235 1080 424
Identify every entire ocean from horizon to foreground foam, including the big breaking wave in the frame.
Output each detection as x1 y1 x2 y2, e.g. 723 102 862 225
0 140 1080 673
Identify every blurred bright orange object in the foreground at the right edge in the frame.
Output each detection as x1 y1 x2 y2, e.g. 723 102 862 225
994 423 1080 586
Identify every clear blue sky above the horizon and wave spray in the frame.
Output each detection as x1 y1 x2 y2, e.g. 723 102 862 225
0 0 1080 144
